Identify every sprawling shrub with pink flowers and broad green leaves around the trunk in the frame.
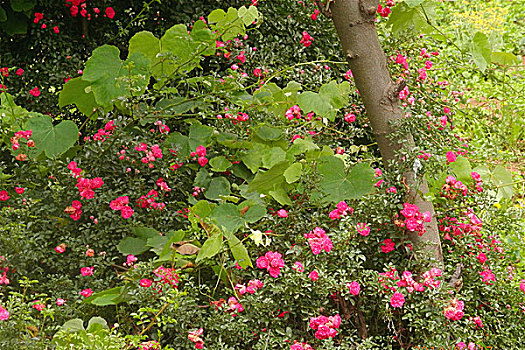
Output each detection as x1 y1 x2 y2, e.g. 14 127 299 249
0 1 525 350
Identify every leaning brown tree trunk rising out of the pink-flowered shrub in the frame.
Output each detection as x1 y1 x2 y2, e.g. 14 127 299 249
330 0 443 266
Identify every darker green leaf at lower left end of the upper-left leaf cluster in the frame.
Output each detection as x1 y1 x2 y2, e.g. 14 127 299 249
58 77 99 116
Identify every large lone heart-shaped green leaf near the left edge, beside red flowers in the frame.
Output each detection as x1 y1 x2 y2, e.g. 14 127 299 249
26 115 78 158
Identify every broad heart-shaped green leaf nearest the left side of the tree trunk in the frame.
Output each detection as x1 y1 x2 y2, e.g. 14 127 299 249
318 156 375 202
